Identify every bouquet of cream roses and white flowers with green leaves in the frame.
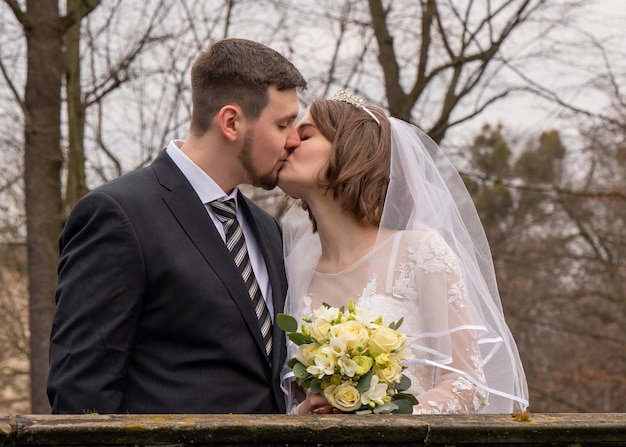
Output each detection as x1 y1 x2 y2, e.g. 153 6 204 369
276 301 417 414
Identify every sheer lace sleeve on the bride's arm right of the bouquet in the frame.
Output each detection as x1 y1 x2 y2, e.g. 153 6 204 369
404 232 488 414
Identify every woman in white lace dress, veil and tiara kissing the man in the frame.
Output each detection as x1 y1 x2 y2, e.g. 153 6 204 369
278 90 528 414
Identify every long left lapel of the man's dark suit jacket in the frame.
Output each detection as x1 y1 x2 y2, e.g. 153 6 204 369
152 151 271 366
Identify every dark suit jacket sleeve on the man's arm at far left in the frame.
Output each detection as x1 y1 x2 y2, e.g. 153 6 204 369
48 192 145 413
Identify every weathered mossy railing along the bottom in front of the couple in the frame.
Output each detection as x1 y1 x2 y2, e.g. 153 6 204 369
0 413 626 447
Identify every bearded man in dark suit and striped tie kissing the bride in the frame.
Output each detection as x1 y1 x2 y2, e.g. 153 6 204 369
48 39 306 413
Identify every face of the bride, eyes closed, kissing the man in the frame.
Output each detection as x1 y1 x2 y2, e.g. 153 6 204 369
278 112 332 198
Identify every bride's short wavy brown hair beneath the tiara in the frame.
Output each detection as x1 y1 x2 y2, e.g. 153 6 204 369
304 99 391 229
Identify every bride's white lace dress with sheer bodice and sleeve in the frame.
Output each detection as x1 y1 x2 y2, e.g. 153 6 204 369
290 231 488 414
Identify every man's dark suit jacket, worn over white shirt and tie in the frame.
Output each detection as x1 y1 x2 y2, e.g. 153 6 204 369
48 152 287 413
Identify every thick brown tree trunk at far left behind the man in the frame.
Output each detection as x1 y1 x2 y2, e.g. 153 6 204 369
24 0 63 413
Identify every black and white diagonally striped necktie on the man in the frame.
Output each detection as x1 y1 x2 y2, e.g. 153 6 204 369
211 199 272 358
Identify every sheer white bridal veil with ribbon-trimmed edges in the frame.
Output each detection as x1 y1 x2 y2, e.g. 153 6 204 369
283 118 528 413
